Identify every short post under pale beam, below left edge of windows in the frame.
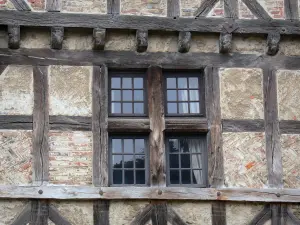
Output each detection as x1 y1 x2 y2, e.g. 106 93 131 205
93 200 109 225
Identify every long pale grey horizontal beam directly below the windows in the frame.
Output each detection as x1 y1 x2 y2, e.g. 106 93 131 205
0 185 300 203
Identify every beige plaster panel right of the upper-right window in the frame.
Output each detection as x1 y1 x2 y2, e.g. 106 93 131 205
219 68 264 119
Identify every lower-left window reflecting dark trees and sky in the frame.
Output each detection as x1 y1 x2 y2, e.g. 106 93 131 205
110 136 148 186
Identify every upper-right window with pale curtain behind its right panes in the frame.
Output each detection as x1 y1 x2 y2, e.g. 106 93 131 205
165 72 204 116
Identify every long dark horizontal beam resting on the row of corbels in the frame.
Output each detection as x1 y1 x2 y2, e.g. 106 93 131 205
0 10 300 34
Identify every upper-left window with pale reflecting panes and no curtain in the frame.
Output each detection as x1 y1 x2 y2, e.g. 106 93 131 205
109 71 146 116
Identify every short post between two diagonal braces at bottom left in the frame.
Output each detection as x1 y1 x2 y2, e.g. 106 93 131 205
29 199 49 225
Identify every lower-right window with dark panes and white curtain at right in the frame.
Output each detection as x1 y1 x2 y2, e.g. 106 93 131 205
166 135 207 187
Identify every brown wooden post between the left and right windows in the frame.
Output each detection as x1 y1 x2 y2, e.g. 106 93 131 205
147 66 166 186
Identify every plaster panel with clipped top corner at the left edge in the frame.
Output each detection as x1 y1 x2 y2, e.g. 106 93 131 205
0 65 33 115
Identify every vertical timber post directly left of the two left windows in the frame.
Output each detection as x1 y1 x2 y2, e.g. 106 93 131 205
92 65 108 187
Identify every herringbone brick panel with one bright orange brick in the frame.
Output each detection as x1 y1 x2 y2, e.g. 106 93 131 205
223 132 268 188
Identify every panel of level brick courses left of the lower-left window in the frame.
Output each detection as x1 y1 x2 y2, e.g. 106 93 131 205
49 131 93 185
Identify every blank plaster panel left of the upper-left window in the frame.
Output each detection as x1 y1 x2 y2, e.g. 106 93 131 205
49 66 93 116
